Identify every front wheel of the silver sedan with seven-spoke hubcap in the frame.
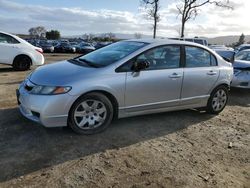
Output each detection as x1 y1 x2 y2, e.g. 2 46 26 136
68 93 114 135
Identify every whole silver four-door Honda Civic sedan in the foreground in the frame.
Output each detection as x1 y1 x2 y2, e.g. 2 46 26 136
17 40 233 134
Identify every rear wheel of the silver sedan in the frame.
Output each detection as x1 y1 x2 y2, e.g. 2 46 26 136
206 86 228 114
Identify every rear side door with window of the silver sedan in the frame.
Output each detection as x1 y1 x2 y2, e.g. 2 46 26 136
181 46 220 104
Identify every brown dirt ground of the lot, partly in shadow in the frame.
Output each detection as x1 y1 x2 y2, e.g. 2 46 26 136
0 54 250 188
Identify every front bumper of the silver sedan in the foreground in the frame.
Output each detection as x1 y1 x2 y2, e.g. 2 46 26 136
17 84 77 127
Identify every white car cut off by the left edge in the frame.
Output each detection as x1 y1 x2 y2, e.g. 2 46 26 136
0 32 44 71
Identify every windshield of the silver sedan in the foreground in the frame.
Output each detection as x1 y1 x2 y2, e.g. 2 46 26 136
78 41 147 67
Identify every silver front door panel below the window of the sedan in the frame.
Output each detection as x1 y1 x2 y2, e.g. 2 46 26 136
125 68 183 112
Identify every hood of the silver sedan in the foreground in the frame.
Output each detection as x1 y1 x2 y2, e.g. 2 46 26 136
29 61 97 86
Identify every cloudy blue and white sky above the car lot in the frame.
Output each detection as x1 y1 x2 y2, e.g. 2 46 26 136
0 0 250 37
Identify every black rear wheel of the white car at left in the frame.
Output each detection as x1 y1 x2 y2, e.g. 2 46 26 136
13 55 32 71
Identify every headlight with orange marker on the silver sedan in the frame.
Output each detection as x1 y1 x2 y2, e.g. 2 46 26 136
30 85 71 95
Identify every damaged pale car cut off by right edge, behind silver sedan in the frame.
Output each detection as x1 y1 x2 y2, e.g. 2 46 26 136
231 49 250 89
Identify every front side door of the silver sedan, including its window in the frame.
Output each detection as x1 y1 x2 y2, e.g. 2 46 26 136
125 45 183 112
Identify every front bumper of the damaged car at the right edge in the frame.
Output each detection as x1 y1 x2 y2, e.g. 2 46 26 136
231 71 250 89
